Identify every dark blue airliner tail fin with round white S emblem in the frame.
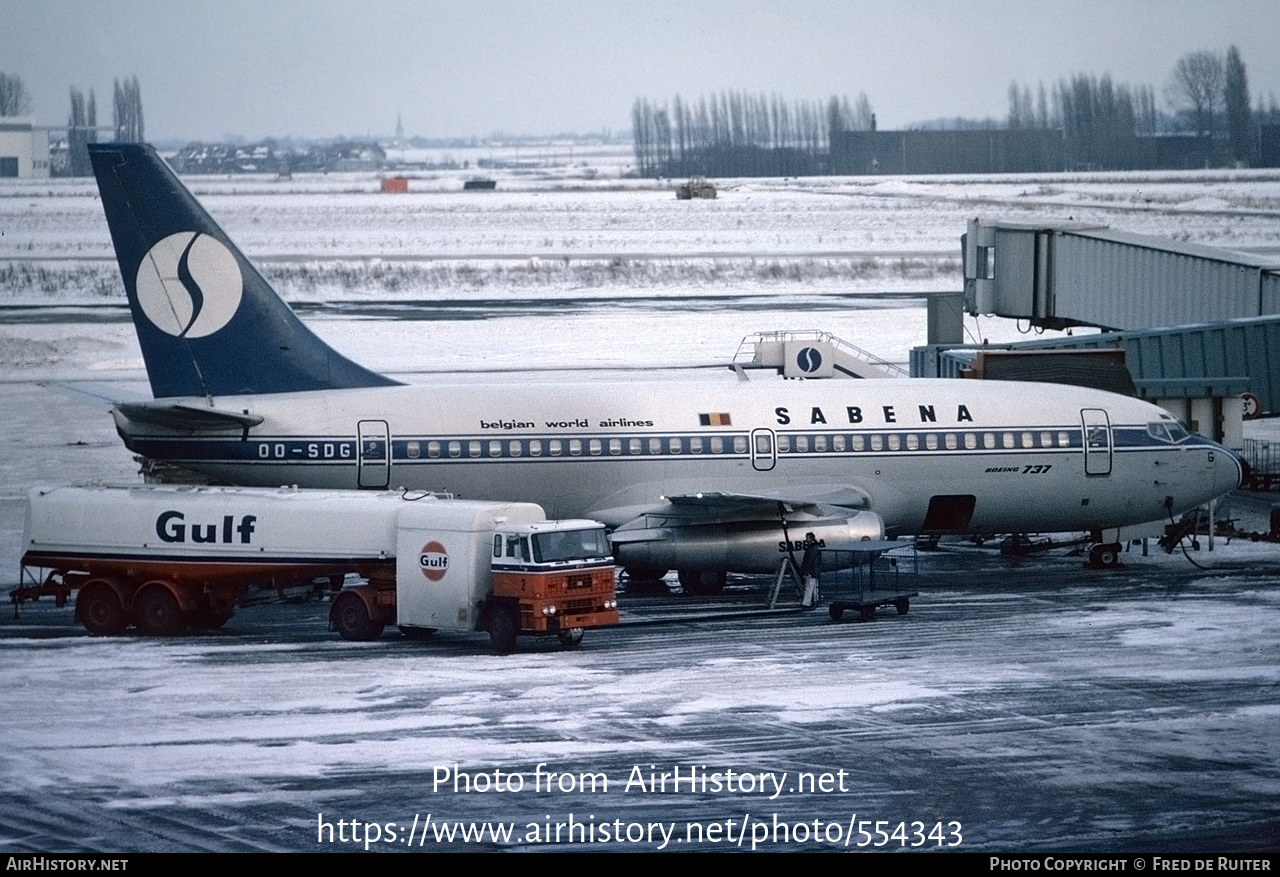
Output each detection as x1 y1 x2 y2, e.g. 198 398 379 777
90 143 397 398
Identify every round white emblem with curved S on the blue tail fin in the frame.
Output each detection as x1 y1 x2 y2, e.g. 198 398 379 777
136 232 244 338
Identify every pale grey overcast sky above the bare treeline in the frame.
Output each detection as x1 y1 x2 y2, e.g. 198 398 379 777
0 0 1280 140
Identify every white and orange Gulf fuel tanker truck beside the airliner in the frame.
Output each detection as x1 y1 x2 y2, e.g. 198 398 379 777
10 487 618 653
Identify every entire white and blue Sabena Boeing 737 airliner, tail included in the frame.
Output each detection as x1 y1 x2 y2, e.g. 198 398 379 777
82 143 1243 591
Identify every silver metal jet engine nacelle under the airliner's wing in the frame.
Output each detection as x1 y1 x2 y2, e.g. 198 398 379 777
612 512 884 574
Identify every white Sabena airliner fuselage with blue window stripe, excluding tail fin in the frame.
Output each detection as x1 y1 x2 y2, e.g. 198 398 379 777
116 379 1240 533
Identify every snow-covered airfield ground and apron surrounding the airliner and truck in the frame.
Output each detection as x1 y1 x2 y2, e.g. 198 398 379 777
0 162 1280 854
